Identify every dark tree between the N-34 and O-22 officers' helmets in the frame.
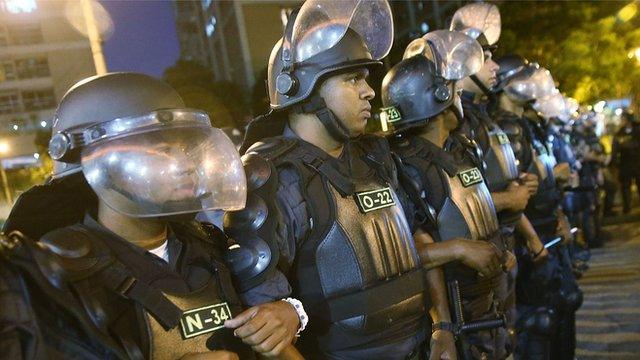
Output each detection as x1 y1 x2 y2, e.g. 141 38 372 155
163 60 249 129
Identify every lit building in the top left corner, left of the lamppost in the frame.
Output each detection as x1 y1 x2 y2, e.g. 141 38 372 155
0 0 96 167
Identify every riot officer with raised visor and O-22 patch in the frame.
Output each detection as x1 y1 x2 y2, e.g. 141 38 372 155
224 0 427 359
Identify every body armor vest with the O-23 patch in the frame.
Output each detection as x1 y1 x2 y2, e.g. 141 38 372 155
393 136 506 298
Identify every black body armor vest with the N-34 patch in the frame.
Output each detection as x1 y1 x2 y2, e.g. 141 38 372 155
0 223 254 359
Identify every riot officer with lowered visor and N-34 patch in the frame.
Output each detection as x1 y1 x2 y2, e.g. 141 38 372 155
0 73 299 359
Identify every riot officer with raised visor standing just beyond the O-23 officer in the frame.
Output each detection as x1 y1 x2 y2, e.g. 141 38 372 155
450 3 547 358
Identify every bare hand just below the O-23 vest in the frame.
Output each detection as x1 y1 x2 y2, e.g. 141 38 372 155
455 238 503 276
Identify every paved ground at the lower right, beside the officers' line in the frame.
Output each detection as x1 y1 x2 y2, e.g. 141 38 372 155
576 222 640 360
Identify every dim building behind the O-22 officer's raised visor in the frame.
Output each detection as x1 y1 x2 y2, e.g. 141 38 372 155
175 0 463 104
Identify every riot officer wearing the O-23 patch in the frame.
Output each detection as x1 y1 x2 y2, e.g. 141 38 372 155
382 30 515 358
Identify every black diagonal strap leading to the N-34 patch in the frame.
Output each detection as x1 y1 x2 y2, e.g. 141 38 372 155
103 263 182 331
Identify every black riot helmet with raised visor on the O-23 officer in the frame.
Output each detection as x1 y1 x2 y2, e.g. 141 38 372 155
382 30 483 132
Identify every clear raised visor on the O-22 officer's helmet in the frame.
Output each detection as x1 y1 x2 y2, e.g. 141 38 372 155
291 0 393 62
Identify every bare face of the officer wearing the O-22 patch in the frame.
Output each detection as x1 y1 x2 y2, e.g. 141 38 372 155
320 68 376 137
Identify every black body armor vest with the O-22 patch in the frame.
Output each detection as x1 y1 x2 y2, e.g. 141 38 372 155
248 136 428 354
